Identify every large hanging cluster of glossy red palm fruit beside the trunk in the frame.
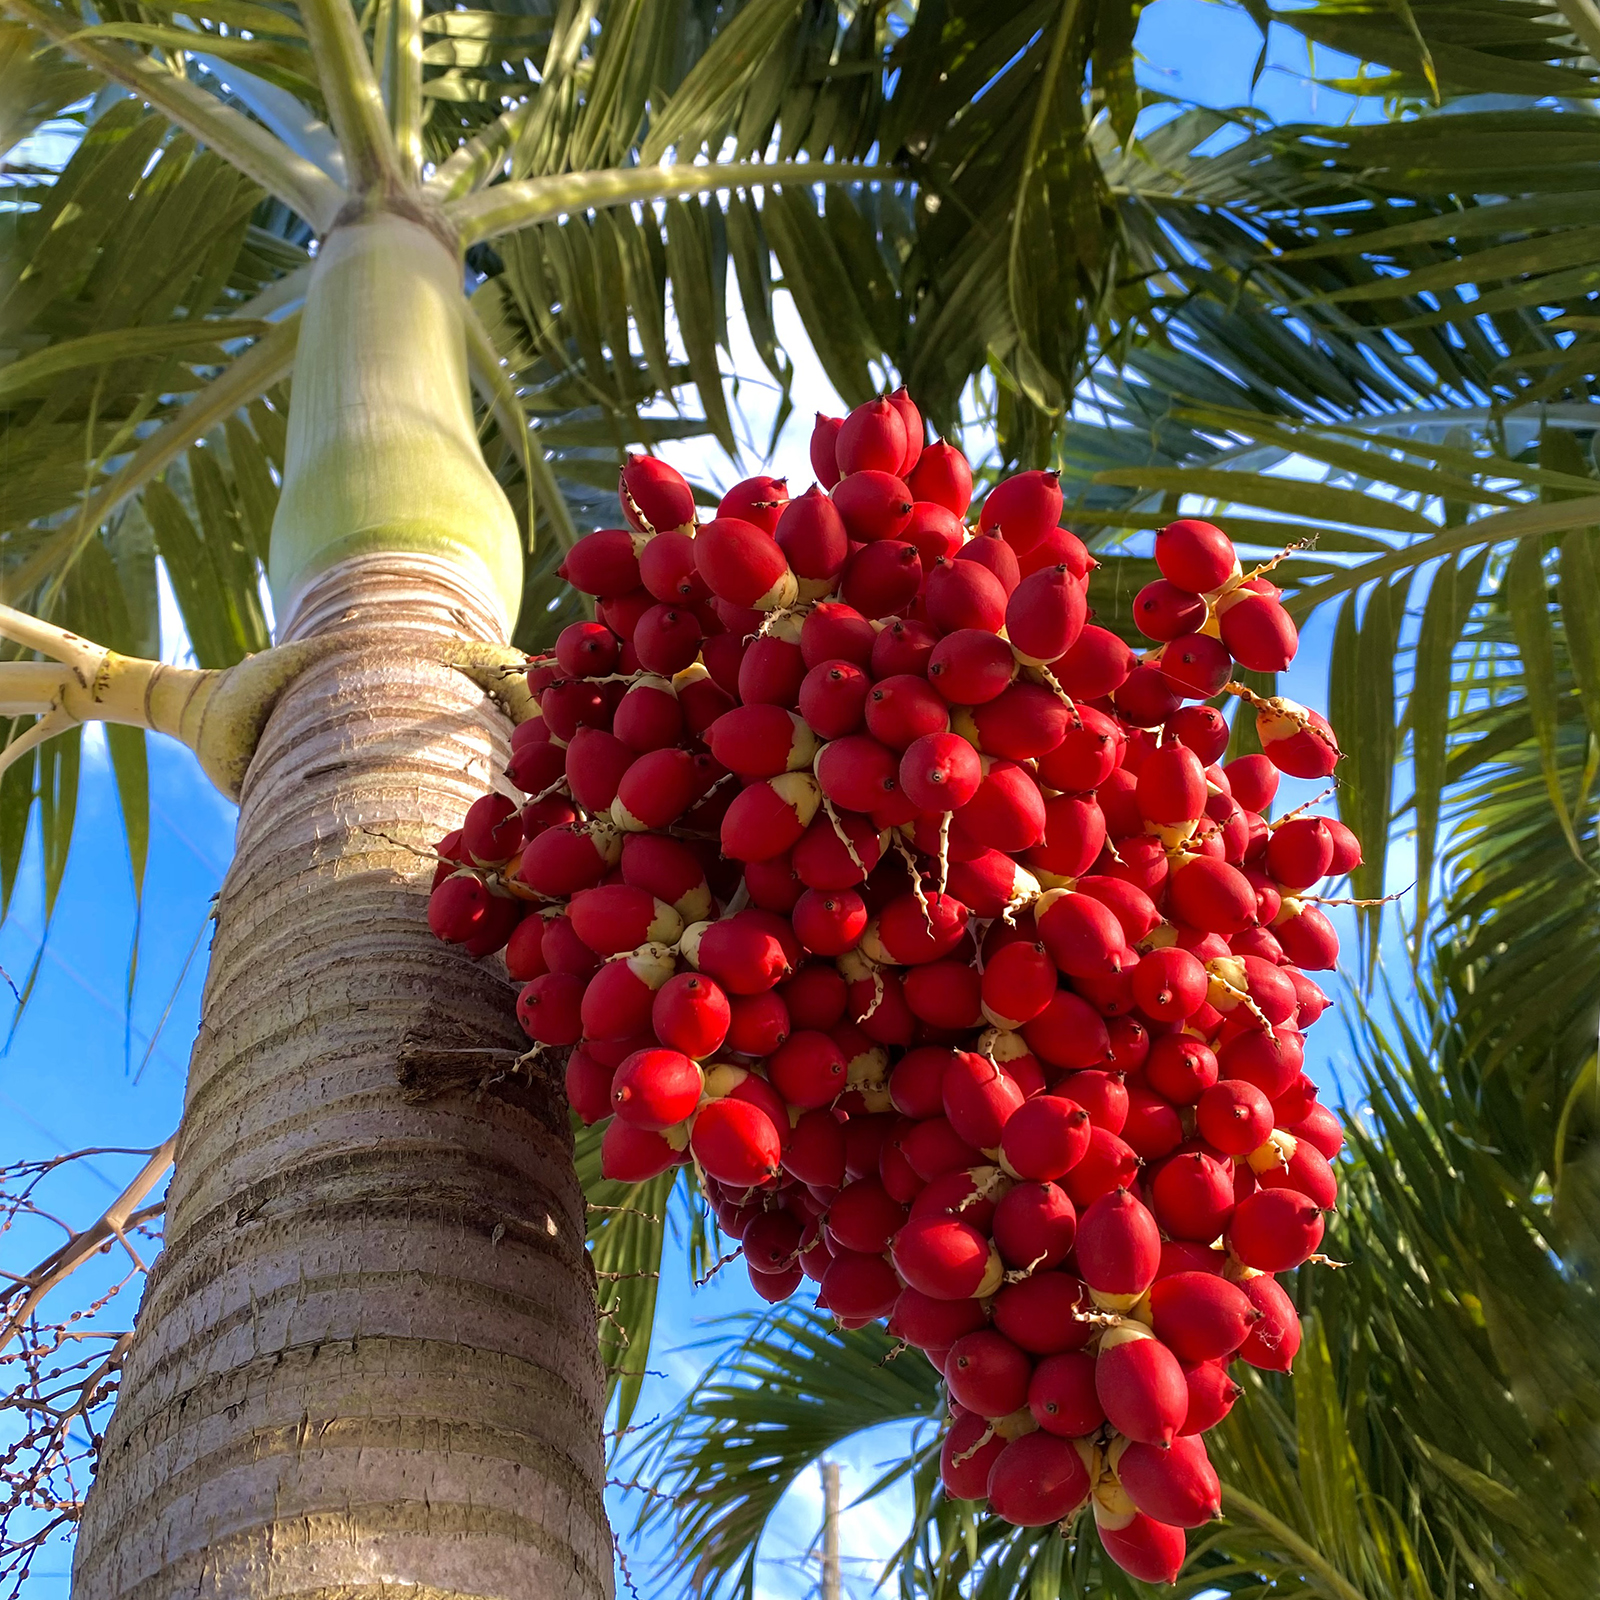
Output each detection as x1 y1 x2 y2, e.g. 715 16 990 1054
429 392 1360 1581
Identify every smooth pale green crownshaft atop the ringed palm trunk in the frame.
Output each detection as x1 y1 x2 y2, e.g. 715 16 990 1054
267 213 522 629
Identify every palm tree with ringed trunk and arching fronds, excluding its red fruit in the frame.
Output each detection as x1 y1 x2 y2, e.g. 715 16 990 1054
0 0 1184 1597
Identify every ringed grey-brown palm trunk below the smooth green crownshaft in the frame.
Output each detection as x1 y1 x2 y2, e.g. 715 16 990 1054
74 216 613 1600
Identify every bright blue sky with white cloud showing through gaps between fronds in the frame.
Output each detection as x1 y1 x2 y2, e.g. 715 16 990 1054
0 0 1406 1600
